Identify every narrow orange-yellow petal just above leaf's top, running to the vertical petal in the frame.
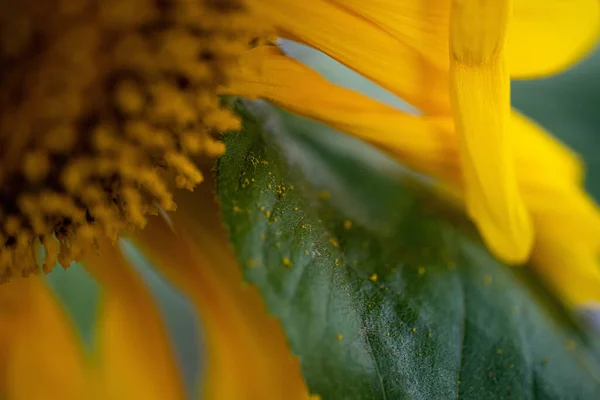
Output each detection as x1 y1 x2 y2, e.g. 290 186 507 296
223 47 459 181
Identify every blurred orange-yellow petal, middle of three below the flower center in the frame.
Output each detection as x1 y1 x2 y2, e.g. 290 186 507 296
85 242 184 400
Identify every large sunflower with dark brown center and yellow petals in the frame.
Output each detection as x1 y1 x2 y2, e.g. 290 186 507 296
0 0 600 399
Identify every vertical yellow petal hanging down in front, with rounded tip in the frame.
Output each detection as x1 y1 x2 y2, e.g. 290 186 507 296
450 0 533 263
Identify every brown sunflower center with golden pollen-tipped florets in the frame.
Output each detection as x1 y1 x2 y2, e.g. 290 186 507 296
0 0 255 282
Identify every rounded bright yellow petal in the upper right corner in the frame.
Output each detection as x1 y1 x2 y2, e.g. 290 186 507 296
506 0 600 78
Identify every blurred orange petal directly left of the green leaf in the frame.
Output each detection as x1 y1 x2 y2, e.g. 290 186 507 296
137 183 316 400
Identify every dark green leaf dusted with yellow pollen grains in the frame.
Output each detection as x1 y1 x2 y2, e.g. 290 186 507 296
218 104 600 400
